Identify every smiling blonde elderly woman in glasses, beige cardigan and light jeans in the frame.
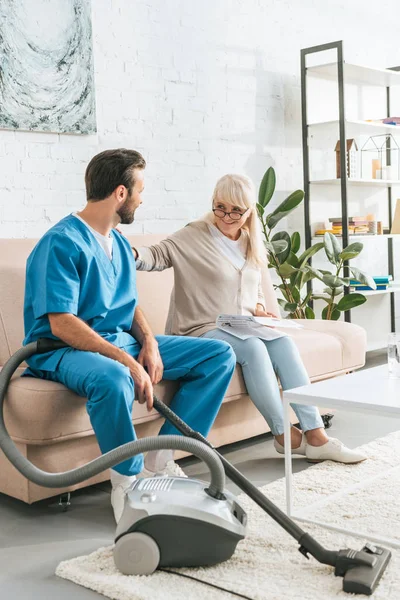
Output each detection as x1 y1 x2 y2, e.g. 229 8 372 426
133 175 366 463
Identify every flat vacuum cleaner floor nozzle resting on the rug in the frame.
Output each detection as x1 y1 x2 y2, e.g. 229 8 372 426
335 544 392 596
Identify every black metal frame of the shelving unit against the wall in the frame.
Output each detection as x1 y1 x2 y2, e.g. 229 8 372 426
301 41 400 332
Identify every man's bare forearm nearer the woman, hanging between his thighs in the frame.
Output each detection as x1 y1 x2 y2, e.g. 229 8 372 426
131 306 164 385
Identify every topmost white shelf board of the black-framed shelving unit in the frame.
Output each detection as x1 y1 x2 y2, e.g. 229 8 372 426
307 62 400 87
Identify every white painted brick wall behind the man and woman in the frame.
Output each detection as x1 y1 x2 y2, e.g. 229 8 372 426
0 0 400 237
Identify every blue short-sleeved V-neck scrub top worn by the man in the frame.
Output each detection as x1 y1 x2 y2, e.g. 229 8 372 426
23 215 137 371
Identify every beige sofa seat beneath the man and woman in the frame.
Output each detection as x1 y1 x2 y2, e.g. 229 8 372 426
5 320 365 445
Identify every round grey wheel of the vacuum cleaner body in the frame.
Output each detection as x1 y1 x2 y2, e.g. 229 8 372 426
114 533 160 575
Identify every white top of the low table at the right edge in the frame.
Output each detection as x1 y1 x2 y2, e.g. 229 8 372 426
283 364 400 417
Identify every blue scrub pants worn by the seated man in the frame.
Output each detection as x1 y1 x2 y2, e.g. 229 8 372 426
31 336 236 475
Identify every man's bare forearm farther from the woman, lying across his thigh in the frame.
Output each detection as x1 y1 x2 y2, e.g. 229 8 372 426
48 313 155 410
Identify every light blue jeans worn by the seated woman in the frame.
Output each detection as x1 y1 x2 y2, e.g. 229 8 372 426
202 329 324 435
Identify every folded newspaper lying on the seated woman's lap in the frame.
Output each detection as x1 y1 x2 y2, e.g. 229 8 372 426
216 315 302 341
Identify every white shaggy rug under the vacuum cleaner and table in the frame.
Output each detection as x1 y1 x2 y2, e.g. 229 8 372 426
56 432 400 600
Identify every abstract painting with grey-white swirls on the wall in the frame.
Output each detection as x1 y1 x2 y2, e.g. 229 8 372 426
0 0 96 134
